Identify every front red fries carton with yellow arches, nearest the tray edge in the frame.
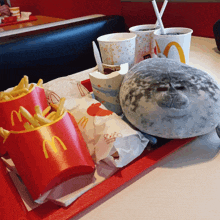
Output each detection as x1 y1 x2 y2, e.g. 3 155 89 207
5 113 95 200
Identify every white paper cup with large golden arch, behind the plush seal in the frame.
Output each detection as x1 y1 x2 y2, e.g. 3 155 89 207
153 27 193 64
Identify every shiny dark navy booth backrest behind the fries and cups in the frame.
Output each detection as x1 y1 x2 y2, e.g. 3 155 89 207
0 15 128 91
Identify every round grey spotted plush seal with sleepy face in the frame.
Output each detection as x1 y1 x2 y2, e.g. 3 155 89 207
119 58 220 138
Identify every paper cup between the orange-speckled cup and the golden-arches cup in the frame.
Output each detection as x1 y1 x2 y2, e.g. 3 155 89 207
129 24 160 64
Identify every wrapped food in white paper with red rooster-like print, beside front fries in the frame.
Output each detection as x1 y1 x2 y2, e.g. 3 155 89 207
69 96 149 167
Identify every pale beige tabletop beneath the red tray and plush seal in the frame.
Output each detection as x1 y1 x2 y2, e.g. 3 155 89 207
72 36 220 220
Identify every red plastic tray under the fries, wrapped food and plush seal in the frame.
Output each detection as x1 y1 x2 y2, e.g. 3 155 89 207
0 80 195 220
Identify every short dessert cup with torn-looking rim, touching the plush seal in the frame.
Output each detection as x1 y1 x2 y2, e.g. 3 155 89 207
89 63 129 114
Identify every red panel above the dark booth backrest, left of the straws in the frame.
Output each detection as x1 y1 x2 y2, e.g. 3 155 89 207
10 0 121 19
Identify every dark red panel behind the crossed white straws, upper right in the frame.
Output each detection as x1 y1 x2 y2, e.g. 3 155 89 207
122 2 220 37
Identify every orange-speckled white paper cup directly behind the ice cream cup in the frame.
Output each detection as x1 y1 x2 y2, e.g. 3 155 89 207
97 33 136 68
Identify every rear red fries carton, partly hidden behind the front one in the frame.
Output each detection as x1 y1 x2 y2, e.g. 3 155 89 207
0 86 48 156
